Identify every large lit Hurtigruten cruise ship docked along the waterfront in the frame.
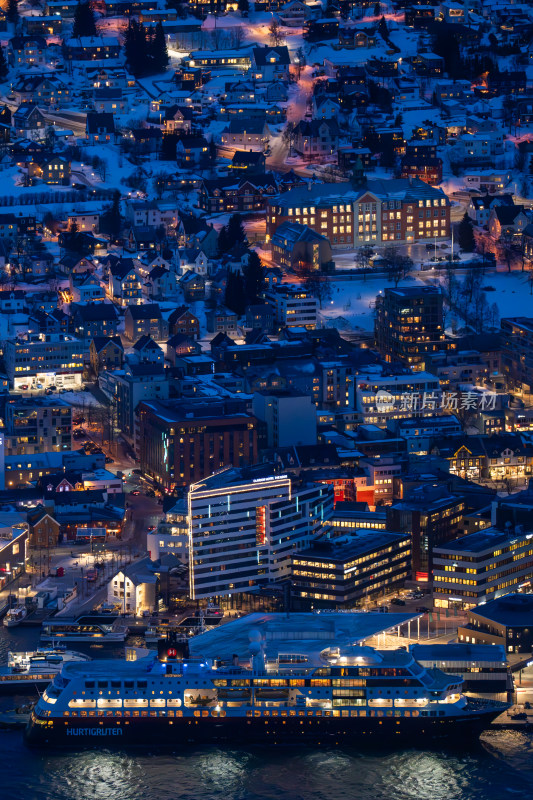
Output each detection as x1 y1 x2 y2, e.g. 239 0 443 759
26 640 507 747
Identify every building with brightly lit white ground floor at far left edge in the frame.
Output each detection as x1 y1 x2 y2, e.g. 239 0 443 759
4 333 83 391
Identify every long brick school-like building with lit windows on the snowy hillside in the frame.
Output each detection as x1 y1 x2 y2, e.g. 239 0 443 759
267 178 450 250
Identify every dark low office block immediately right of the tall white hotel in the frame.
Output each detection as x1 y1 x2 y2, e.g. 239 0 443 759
292 528 411 607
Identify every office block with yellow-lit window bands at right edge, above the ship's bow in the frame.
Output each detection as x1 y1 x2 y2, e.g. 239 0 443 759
433 525 533 608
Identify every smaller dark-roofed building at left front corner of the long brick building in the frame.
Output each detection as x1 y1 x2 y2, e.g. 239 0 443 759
272 222 333 270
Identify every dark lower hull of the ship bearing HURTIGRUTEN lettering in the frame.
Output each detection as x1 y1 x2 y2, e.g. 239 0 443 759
25 709 501 749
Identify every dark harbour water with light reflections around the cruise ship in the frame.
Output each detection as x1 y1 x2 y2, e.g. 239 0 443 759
0 629 533 800
